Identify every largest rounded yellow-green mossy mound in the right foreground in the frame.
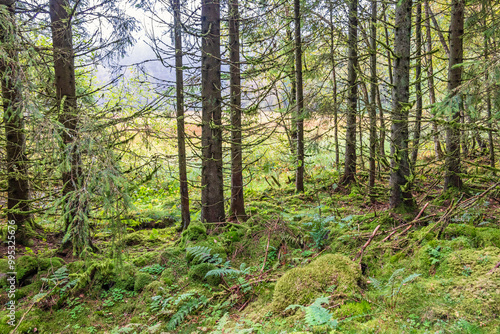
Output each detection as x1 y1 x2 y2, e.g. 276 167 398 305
272 254 361 312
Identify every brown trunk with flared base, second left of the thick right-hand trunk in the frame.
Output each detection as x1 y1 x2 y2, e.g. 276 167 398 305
340 0 358 185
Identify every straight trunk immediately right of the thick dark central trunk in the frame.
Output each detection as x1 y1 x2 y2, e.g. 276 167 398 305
229 0 246 220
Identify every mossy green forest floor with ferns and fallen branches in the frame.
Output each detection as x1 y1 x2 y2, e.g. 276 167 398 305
0 167 500 333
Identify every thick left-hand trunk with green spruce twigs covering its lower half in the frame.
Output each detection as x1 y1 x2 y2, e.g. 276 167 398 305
50 0 94 254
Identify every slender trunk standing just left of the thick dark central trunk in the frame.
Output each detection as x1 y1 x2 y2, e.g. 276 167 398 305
172 0 191 230
